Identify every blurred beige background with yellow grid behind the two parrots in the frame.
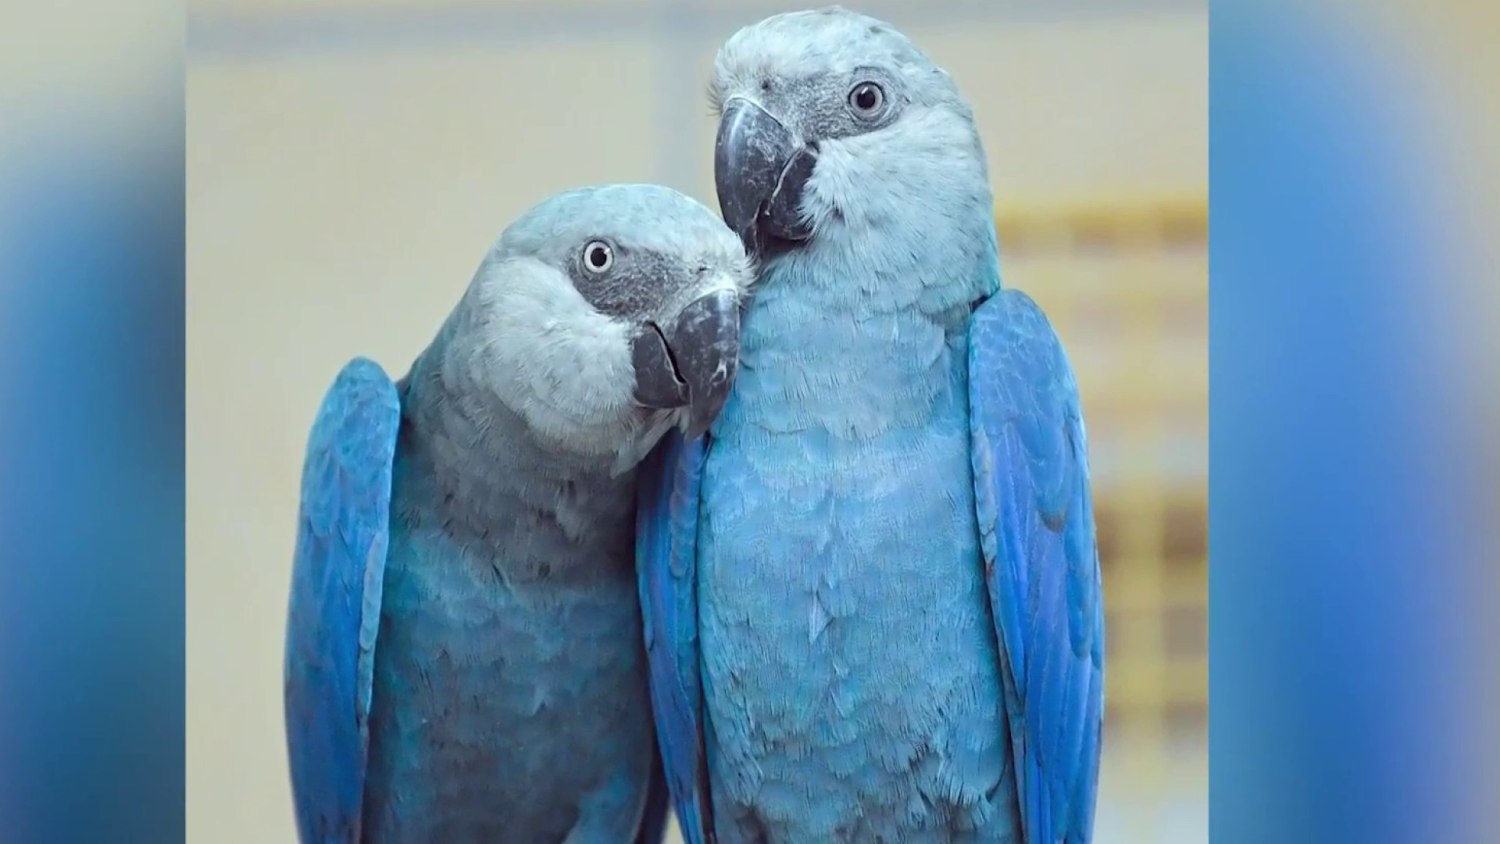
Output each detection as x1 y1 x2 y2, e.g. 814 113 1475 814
186 0 1208 844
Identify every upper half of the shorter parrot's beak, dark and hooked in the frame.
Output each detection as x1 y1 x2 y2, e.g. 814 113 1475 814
671 289 740 439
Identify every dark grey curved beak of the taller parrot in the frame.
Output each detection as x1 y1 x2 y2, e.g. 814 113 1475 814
714 97 818 255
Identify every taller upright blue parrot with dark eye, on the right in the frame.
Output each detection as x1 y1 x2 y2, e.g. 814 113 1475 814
636 7 1104 844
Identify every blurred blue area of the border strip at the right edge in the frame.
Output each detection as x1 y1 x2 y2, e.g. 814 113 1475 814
1209 1 1500 844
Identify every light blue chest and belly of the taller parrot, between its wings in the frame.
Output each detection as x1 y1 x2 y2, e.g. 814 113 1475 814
699 275 1013 840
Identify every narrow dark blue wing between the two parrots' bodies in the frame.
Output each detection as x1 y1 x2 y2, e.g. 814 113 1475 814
636 430 714 844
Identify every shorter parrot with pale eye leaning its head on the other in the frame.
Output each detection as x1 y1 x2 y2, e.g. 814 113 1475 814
285 186 753 844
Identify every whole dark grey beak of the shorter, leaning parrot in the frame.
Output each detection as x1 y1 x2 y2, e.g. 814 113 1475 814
630 289 740 439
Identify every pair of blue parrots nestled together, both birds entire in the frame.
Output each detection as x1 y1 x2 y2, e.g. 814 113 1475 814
285 7 1104 844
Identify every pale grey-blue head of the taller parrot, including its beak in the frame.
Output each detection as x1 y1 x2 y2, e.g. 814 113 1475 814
710 7 993 259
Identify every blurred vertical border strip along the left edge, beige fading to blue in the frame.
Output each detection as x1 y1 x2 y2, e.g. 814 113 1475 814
0 3 186 844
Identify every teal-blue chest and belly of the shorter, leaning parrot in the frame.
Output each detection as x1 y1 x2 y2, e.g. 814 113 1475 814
365 446 653 841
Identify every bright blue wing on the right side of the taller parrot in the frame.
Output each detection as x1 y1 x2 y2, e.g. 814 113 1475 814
969 291 1104 844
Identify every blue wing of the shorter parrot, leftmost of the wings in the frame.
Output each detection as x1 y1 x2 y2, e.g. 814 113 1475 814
285 358 401 844
